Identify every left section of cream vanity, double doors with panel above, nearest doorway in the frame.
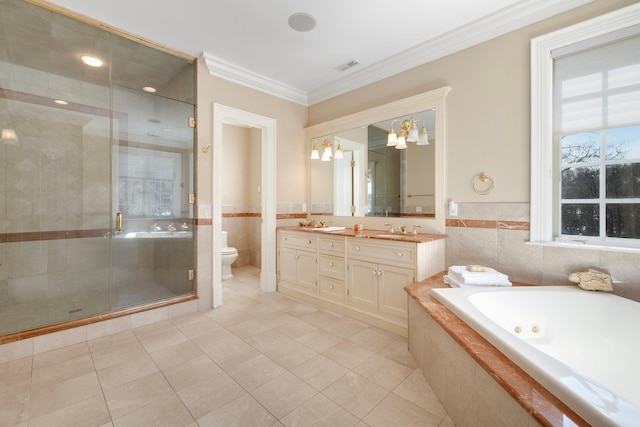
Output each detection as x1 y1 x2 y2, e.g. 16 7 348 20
278 233 318 294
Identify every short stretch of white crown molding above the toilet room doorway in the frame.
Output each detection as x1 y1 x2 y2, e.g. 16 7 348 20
200 52 309 106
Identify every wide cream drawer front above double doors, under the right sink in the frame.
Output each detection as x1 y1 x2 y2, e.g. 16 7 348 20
347 239 416 266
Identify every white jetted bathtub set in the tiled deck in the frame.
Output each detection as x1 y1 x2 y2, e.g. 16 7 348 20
432 286 640 426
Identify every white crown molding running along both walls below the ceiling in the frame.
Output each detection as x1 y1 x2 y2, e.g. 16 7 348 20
201 0 594 106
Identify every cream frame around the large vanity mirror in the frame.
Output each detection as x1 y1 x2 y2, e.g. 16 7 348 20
305 86 452 233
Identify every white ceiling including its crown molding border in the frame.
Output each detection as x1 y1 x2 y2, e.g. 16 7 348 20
41 0 593 105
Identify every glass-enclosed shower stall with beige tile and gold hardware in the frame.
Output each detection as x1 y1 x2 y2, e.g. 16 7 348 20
0 0 196 338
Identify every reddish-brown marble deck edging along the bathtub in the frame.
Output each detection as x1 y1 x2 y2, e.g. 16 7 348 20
405 272 589 426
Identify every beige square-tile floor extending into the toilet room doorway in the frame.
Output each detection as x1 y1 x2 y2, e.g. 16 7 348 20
0 267 453 427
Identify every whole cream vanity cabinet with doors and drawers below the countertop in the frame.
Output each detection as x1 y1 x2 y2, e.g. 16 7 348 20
278 230 444 335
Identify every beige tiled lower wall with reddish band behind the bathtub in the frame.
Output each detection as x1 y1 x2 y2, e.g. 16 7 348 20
445 203 640 300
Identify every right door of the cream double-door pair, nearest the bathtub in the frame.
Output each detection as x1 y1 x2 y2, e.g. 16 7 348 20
378 264 414 319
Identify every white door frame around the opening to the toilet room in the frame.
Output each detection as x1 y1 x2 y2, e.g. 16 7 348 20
211 102 276 308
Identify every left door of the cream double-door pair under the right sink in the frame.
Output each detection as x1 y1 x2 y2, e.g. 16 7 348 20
347 260 378 312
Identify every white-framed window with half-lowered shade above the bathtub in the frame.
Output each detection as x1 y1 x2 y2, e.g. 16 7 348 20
531 5 640 248
